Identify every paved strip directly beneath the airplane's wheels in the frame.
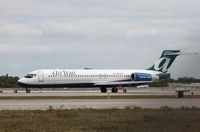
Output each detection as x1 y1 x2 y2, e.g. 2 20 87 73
0 88 200 97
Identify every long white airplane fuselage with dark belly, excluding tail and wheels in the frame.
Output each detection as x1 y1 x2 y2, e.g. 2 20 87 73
18 69 161 87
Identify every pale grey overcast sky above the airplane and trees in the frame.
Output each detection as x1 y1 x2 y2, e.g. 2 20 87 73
0 0 200 78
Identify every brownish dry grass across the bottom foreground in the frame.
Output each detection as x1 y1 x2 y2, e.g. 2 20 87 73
0 107 200 132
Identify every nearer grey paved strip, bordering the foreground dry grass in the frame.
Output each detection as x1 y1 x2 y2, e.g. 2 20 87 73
0 99 200 110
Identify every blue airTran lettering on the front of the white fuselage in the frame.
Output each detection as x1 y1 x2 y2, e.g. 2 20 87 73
52 70 76 77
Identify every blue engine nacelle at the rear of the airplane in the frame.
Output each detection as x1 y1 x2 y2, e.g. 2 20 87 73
131 73 153 81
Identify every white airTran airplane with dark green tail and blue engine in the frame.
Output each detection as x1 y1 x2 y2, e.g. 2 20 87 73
17 50 181 93
